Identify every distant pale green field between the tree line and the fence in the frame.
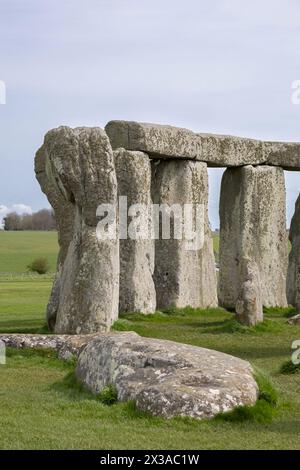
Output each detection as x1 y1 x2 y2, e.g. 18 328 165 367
0 231 58 275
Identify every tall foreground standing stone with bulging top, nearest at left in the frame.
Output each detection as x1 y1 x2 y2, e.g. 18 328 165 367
37 127 119 334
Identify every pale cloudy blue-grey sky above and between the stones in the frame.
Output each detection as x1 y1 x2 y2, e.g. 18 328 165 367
0 0 300 228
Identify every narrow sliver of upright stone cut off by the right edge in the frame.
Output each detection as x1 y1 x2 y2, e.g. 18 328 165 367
287 195 300 310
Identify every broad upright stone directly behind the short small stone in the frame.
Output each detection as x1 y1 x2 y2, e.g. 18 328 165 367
219 166 288 320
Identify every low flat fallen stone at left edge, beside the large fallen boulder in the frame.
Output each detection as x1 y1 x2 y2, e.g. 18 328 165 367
0 334 97 360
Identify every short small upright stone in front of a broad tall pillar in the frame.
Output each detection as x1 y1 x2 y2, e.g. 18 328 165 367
235 259 263 326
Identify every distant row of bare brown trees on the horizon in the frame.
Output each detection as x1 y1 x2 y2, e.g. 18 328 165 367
3 209 56 230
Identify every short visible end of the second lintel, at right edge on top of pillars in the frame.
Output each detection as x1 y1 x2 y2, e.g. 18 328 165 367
264 142 300 171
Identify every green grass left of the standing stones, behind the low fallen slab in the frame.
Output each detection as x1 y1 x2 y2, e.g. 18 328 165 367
0 231 58 332
